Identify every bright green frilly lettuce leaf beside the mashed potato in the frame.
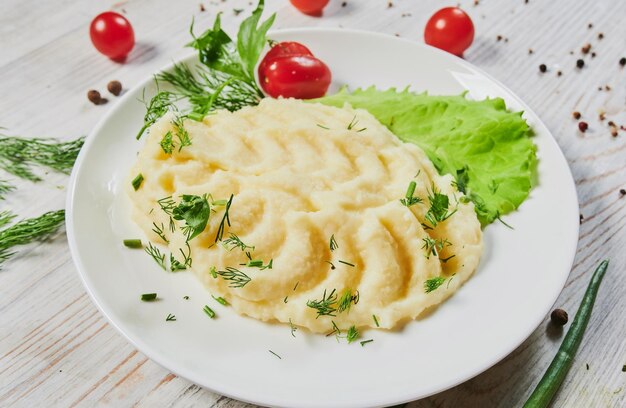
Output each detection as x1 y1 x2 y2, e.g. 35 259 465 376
314 87 537 226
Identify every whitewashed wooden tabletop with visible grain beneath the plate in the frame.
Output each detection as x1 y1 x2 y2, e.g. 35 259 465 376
0 0 626 407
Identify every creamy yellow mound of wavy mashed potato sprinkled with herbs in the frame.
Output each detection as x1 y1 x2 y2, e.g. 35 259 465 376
129 99 482 332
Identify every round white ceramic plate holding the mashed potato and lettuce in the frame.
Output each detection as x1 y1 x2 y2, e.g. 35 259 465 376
67 29 578 408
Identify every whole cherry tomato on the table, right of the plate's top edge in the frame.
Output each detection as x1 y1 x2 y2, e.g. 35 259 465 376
424 7 474 57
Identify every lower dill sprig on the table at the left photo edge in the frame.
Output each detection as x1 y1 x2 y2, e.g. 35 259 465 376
0 210 65 266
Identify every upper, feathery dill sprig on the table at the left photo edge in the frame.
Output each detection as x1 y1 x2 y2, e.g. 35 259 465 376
0 134 85 182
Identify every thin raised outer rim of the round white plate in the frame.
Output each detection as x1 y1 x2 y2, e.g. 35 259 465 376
65 27 580 407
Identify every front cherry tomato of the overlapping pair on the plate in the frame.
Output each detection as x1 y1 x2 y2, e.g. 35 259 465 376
259 55 331 99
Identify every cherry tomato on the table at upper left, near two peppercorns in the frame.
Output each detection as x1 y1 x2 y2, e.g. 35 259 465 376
89 11 135 59
